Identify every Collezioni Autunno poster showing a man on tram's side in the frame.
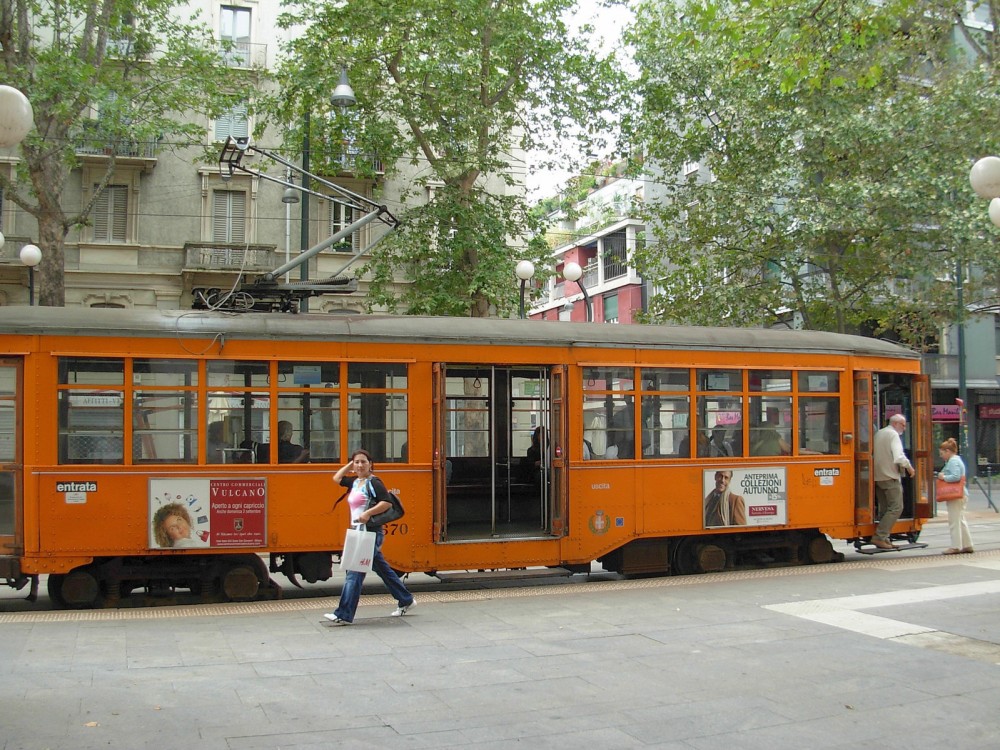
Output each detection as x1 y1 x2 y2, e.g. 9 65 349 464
702 466 788 529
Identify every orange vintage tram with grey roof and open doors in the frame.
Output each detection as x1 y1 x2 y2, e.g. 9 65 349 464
0 307 933 608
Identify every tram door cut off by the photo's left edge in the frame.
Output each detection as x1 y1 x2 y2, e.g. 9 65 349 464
0 359 23 577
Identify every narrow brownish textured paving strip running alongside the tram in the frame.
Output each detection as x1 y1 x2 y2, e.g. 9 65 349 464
0 549 1000 624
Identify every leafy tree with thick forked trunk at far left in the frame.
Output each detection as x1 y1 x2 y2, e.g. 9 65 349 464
0 0 250 306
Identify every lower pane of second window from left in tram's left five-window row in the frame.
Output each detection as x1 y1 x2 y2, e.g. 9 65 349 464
132 390 198 463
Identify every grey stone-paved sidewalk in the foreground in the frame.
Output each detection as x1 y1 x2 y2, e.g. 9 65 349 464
0 502 1000 750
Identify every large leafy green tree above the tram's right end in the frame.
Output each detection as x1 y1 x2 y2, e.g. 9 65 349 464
629 0 1000 343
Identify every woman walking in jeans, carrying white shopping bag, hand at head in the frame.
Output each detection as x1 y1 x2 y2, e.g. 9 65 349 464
323 449 416 625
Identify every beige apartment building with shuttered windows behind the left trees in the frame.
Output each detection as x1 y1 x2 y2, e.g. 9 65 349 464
0 0 480 313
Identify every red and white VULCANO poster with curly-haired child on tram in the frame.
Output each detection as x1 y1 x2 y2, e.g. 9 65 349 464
149 477 267 549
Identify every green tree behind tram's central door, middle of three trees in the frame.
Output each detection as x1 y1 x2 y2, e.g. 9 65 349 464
279 0 616 317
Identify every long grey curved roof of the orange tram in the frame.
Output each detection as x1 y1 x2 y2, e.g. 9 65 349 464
0 306 920 359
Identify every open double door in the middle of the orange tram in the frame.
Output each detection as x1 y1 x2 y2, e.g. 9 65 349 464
434 364 564 541
